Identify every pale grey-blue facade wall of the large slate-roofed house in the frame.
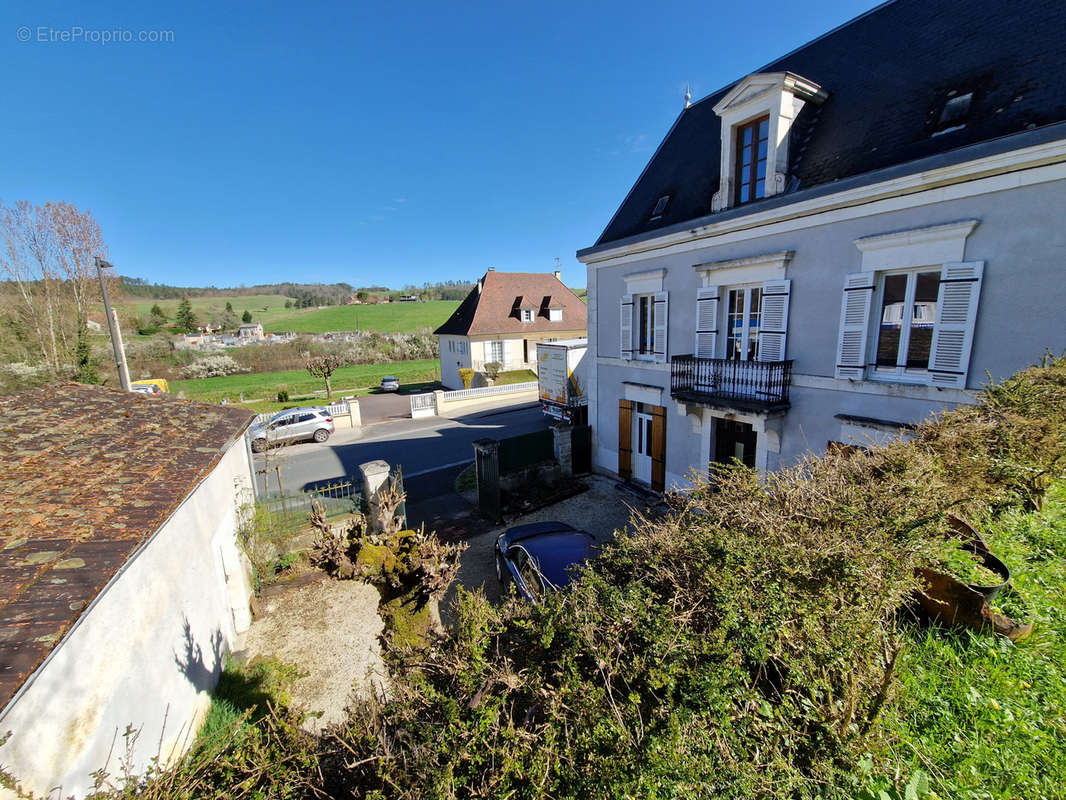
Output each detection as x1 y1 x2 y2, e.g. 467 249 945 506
588 171 1066 485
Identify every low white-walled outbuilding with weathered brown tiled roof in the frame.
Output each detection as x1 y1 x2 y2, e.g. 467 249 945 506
0 383 253 798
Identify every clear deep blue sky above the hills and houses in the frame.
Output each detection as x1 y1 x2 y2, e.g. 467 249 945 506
0 0 875 288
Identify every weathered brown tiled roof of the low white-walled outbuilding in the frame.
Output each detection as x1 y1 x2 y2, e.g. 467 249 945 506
0 383 252 706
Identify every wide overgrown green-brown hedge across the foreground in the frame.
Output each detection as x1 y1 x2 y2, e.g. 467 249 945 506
37 361 1066 798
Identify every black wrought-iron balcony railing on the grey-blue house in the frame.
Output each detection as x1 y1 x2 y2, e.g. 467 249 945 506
669 355 792 411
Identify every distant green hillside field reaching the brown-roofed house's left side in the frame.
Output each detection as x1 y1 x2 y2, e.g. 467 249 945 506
261 300 459 333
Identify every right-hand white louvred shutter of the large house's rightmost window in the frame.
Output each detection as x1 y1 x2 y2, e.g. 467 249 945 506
930 261 985 389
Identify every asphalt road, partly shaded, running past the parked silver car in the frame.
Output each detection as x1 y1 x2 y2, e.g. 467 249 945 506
255 404 549 501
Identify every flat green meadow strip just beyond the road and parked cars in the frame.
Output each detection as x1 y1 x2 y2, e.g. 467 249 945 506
171 358 439 411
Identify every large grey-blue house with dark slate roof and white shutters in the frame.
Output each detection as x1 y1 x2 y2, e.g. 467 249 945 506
578 0 1066 491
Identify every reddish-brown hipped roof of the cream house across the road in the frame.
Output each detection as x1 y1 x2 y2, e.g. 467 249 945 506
434 270 587 336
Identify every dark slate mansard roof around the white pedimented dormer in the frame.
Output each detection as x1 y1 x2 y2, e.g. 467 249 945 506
583 0 1066 252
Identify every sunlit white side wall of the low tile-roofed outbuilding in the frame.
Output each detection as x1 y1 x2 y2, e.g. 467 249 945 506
0 437 252 798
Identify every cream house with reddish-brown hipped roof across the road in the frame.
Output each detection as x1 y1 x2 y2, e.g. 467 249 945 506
434 269 587 389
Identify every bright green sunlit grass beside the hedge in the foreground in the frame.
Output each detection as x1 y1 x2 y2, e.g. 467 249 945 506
862 480 1066 800
